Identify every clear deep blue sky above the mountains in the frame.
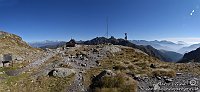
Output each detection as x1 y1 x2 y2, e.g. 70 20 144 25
0 0 200 42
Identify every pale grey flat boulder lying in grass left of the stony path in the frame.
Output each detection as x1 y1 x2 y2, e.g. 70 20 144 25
48 68 76 78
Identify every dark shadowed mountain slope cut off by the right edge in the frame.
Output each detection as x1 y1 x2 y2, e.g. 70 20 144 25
179 48 200 63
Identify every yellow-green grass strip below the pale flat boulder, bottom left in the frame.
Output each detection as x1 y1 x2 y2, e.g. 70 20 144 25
7 75 74 92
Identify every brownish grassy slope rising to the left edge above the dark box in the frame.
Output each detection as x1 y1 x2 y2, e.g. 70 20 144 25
0 31 42 66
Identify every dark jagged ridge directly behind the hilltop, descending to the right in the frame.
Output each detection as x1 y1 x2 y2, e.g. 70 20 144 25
84 36 181 62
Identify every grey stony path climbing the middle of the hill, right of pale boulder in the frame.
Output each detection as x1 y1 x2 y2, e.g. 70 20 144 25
65 47 106 92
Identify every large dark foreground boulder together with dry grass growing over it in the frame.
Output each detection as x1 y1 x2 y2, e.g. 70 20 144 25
90 70 138 92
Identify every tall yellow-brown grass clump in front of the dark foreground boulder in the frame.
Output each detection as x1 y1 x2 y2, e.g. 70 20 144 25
94 74 137 92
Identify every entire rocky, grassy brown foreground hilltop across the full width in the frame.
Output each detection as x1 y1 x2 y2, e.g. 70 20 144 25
0 32 200 92
